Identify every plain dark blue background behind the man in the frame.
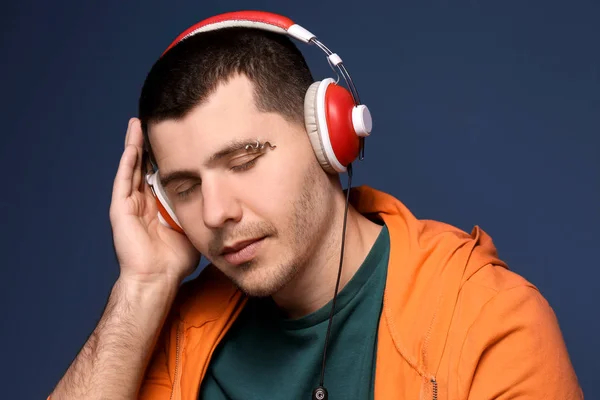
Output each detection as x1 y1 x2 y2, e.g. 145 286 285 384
0 0 600 399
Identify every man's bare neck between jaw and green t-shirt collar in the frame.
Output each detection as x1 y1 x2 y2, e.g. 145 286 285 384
273 191 381 318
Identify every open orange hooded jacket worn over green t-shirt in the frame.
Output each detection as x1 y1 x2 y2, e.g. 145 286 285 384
52 187 583 400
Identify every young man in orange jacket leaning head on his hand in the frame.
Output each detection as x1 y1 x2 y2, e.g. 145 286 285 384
50 10 583 400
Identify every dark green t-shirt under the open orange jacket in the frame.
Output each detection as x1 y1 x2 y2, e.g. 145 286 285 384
199 226 389 400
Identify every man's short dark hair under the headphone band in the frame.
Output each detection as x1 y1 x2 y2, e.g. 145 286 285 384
138 27 313 152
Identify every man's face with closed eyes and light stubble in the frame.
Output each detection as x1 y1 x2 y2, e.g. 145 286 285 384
150 77 333 296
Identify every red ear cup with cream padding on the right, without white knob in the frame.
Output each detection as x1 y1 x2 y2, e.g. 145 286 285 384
304 78 360 173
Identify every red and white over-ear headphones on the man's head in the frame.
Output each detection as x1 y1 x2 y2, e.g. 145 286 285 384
146 11 373 233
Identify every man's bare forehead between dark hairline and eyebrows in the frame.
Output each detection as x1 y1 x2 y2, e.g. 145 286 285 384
149 76 311 171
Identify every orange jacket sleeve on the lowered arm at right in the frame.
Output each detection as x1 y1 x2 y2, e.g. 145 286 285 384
458 285 583 400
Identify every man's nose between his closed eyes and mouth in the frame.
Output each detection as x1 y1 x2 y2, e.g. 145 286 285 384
202 179 242 228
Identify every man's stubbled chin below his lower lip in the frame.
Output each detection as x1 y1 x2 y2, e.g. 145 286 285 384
230 260 298 297
